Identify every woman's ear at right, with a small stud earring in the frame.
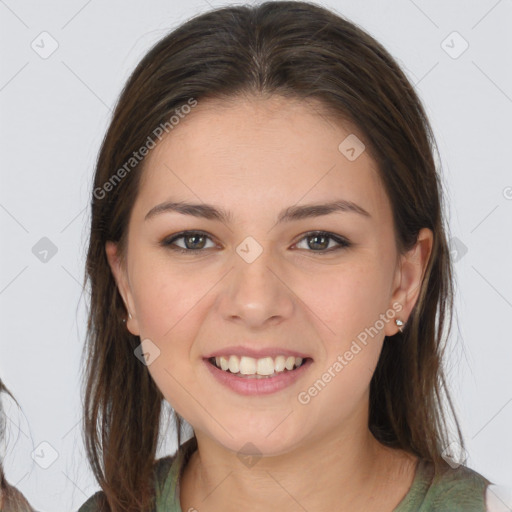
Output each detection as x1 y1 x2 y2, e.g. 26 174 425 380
385 228 434 336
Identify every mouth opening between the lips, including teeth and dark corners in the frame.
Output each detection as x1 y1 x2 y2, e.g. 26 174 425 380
206 355 311 379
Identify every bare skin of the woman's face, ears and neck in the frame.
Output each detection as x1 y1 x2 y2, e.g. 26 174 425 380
106 97 433 512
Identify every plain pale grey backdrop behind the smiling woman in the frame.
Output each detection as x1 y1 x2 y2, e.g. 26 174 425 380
0 0 512 512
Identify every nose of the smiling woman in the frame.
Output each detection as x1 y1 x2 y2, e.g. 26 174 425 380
219 245 294 330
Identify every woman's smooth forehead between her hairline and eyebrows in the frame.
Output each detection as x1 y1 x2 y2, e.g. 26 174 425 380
137 96 390 224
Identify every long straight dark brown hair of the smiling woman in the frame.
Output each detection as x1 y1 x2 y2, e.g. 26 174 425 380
84 1 464 512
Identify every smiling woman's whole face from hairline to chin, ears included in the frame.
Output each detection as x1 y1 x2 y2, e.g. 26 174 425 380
107 97 429 455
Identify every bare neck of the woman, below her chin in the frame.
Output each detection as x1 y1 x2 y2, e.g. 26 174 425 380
180 429 415 512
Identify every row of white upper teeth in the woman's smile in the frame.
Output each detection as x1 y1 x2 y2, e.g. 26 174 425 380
215 356 303 376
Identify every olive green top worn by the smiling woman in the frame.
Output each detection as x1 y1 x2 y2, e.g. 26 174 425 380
78 437 490 512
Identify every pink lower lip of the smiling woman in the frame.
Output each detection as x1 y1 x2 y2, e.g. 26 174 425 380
204 359 313 395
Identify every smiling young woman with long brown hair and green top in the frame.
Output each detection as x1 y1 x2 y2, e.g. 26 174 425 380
80 1 489 512
